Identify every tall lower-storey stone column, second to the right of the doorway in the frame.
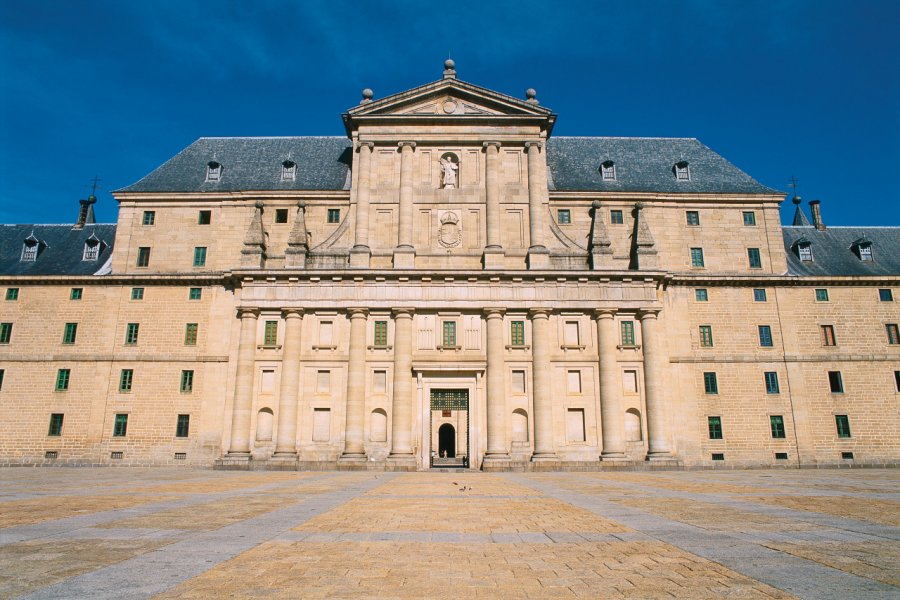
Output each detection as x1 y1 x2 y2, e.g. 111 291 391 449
531 309 557 461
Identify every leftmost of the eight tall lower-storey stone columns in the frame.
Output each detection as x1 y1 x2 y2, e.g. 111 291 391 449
228 308 259 459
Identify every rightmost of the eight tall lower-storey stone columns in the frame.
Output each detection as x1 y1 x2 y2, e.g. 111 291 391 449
638 310 673 460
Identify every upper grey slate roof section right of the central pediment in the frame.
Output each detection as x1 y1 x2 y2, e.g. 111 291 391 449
547 137 781 194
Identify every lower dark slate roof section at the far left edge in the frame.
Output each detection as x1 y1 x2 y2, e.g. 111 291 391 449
0 224 116 275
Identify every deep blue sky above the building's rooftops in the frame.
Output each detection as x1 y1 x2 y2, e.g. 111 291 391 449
0 0 900 225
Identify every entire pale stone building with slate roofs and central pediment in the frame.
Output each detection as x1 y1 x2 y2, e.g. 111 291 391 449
0 61 900 470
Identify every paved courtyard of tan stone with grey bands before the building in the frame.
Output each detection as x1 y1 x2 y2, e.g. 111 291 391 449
0 468 900 600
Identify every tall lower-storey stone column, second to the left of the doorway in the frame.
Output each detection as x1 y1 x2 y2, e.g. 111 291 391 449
341 308 368 460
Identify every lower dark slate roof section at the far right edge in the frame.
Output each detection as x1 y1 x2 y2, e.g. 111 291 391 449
782 227 900 277
